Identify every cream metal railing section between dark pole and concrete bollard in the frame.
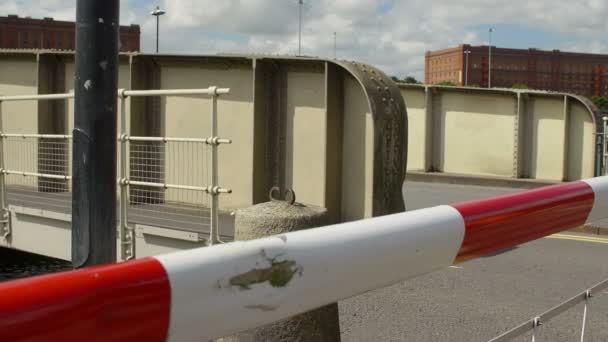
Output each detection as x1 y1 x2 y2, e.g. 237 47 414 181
118 87 231 260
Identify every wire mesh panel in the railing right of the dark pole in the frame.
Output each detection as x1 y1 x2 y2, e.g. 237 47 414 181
129 141 210 230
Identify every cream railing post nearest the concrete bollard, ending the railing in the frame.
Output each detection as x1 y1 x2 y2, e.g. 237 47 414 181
209 87 220 245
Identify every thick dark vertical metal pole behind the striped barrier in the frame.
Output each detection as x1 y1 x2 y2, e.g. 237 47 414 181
72 0 119 268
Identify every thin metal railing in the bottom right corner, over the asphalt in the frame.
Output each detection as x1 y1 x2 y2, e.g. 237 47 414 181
489 279 608 342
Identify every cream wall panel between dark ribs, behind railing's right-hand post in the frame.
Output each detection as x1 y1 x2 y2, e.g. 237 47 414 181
160 63 253 208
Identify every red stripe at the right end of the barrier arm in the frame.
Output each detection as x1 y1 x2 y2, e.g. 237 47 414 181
452 182 595 262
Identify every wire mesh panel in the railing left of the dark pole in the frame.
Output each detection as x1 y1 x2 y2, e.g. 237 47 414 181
4 136 71 213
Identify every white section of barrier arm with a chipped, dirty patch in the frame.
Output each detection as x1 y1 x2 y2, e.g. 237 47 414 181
157 206 465 341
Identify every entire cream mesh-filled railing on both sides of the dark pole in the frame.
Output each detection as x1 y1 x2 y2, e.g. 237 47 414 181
0 87 231 260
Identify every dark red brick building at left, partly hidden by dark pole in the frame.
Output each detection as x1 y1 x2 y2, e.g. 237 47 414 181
0 15 140 51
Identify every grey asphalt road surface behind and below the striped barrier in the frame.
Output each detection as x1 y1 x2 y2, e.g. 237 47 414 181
339 183 608 342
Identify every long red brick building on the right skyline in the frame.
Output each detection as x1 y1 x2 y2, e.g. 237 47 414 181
424 45 608 96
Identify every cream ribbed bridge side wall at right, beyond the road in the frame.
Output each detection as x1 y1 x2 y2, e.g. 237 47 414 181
401 85 595 181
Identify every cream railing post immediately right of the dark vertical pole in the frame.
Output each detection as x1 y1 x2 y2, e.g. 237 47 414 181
118 89 135 260
